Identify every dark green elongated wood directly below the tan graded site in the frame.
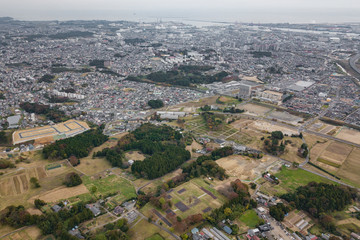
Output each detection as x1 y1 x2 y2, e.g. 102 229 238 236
43 129 108 159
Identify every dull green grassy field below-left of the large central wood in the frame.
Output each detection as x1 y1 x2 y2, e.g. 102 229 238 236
83 175 136 202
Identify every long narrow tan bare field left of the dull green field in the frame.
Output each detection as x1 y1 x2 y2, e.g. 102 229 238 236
29 184 89 202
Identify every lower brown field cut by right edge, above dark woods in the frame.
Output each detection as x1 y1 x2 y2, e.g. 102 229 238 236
337 148 360 185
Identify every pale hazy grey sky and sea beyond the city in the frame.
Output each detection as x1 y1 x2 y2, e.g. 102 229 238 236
0 0 360 22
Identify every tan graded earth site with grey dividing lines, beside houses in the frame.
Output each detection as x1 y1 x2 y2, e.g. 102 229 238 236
13 120 90 145
